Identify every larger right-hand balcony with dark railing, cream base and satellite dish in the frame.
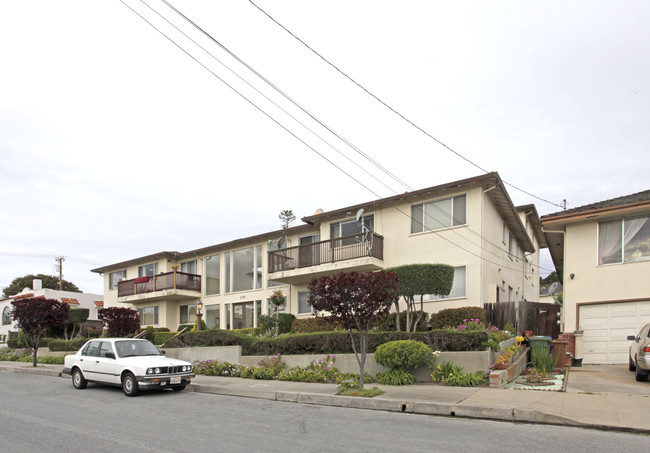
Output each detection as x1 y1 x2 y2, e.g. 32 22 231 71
269 232 384 284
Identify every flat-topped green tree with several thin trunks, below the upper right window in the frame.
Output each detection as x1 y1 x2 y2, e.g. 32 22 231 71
387 264 454 332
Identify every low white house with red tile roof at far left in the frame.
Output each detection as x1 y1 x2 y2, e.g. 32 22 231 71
0 279 104 344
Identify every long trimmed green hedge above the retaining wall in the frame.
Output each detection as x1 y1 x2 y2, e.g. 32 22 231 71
165 330 487 355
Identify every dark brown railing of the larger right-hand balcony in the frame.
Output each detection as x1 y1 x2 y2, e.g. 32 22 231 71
269 232 384 273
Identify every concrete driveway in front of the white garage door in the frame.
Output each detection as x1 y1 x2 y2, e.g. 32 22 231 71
566 365 650 396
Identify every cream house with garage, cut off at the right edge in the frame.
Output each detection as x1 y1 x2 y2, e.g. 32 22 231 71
541 190 650 363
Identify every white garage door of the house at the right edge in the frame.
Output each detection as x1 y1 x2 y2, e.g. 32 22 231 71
579 300 650 364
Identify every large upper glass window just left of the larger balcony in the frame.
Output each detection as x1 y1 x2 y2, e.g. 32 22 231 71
225 245 262 293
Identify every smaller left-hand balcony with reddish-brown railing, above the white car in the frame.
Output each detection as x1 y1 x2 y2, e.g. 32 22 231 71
117 271 201 303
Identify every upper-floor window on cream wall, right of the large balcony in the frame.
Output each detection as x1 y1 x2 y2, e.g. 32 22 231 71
411 195 467 233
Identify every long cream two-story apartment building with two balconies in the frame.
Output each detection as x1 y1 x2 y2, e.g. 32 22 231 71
93 173 546 330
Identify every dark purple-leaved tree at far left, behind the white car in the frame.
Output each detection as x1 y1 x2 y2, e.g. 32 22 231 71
11 298 70 366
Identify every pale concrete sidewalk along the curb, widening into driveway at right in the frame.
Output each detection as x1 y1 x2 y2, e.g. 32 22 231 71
0 362 650 434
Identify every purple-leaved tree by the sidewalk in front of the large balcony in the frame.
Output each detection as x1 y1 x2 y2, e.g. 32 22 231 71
307 271 399 389
